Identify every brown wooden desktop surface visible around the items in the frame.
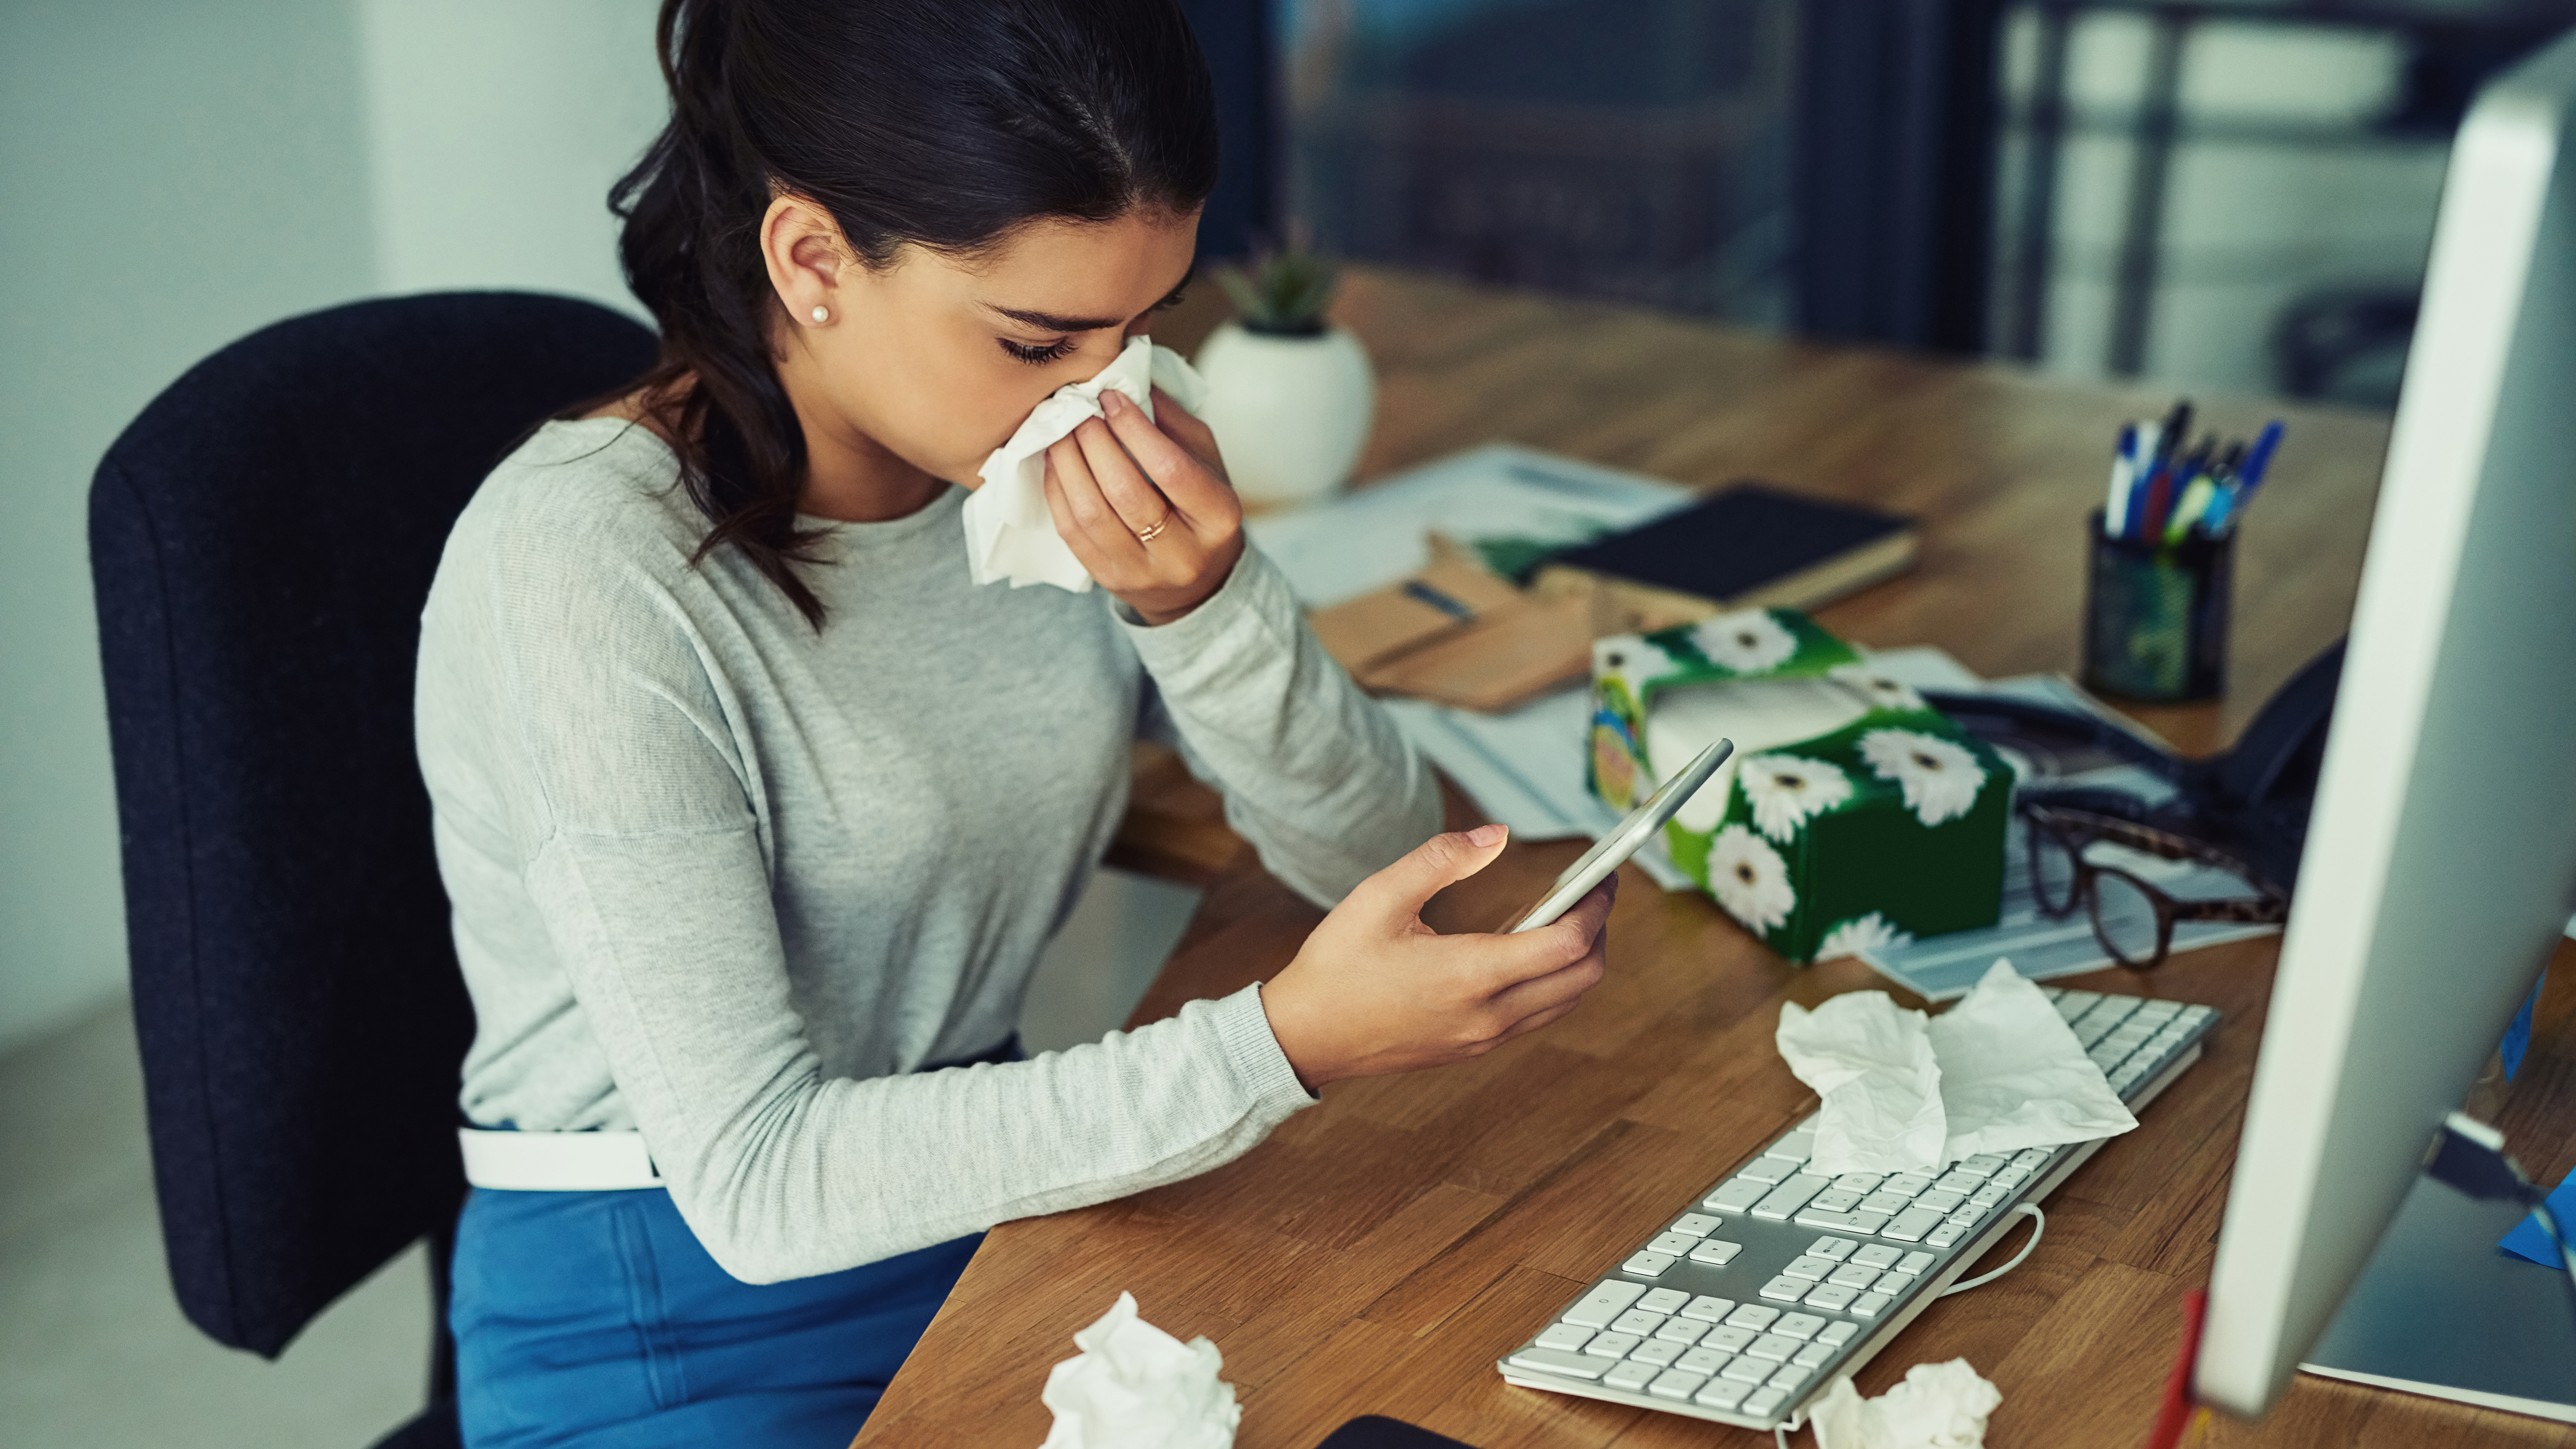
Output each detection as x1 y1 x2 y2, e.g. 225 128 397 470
858 271 2576 1449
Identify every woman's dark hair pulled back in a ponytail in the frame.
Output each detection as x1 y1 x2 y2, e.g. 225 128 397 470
608 0 1216 626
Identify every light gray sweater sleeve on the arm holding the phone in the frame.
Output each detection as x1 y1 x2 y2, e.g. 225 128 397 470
440 492 1311 1282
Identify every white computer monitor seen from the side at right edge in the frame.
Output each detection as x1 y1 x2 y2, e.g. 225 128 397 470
2195 36 2576 1416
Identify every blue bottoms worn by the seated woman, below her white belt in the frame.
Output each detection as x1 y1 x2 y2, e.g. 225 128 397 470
448 1188 984 1449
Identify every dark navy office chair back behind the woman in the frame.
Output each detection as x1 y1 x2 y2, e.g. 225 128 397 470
90 291 654 1449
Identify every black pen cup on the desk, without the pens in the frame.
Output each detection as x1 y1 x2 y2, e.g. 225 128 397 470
2084 508 2236 704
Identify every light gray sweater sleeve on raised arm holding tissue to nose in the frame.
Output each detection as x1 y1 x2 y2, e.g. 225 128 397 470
1121 544 1440 905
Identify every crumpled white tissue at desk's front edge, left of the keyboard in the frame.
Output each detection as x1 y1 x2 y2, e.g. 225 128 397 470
1038 1284 1244 1449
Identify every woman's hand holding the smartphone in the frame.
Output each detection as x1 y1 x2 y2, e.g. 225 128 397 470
1262 825 1618 1091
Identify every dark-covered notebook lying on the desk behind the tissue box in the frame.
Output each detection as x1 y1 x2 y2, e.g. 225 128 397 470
1536 482 1919 619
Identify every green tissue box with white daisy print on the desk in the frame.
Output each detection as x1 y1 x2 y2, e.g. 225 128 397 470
1589 608 2012 962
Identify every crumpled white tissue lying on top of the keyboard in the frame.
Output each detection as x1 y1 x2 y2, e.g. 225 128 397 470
1775 959 2138 1178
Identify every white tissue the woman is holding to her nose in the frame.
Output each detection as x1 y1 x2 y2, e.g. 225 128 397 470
966 338 1208 593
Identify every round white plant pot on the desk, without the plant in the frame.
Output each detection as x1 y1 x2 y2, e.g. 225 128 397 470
1195 322 1378 503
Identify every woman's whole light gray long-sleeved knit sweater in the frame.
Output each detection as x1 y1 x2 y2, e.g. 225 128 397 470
417 420 1440 1282
